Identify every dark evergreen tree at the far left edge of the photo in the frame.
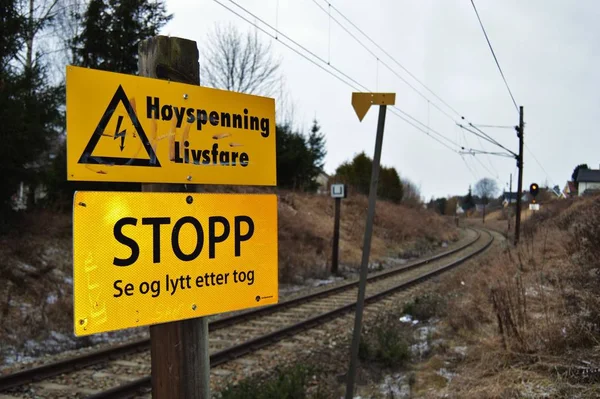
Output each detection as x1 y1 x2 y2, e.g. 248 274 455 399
0 0 64 214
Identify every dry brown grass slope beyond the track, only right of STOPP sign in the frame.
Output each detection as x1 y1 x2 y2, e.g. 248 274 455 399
279 192 458 282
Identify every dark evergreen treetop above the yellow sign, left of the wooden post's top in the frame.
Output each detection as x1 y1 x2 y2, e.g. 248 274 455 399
72 0 172 74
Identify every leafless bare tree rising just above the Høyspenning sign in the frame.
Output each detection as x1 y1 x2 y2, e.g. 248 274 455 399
201 25 281 96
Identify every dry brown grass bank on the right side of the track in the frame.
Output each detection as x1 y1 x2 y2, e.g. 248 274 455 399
434 199 600 398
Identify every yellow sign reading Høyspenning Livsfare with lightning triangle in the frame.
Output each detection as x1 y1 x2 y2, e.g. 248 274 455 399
67 66 277 186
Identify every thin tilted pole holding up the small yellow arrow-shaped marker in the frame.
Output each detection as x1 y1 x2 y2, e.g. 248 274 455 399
346 105 387 399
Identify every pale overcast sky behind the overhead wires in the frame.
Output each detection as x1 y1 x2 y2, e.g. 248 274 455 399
162 0 600 200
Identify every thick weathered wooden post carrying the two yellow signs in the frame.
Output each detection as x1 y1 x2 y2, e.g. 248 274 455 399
138 36 210 399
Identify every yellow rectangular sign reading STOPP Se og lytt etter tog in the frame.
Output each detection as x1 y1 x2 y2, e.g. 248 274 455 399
73 191 278 336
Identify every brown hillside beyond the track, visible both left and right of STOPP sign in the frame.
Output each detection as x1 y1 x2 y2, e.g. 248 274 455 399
0 190 459 370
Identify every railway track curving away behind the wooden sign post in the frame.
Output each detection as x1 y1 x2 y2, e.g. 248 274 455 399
0 230 493 398
